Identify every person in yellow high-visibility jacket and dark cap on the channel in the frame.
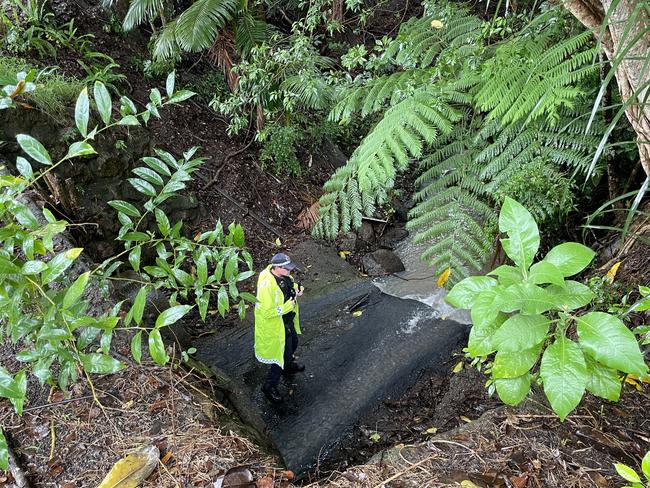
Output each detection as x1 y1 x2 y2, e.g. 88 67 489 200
255 253 305 403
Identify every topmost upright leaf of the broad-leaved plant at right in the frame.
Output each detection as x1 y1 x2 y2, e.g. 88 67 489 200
499 197 539 270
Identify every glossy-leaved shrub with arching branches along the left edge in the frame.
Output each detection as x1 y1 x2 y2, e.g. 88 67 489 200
0 73 254 442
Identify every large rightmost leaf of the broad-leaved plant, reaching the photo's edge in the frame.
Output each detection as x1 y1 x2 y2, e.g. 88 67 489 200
576 312 647 376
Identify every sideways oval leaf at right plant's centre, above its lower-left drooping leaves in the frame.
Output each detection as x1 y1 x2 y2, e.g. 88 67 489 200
492 314 551 352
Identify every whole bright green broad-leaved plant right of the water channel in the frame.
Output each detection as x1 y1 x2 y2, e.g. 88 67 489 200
447 198 648 420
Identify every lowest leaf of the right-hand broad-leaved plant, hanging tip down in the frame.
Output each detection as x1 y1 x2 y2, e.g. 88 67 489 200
540 337 589 420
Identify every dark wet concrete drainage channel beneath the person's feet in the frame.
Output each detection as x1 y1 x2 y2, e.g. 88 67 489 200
185 241 469 474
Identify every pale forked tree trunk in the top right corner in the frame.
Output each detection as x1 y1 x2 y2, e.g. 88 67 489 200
564 0 650 176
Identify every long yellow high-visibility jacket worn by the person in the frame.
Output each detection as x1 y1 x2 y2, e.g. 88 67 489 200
255 265 301 369
